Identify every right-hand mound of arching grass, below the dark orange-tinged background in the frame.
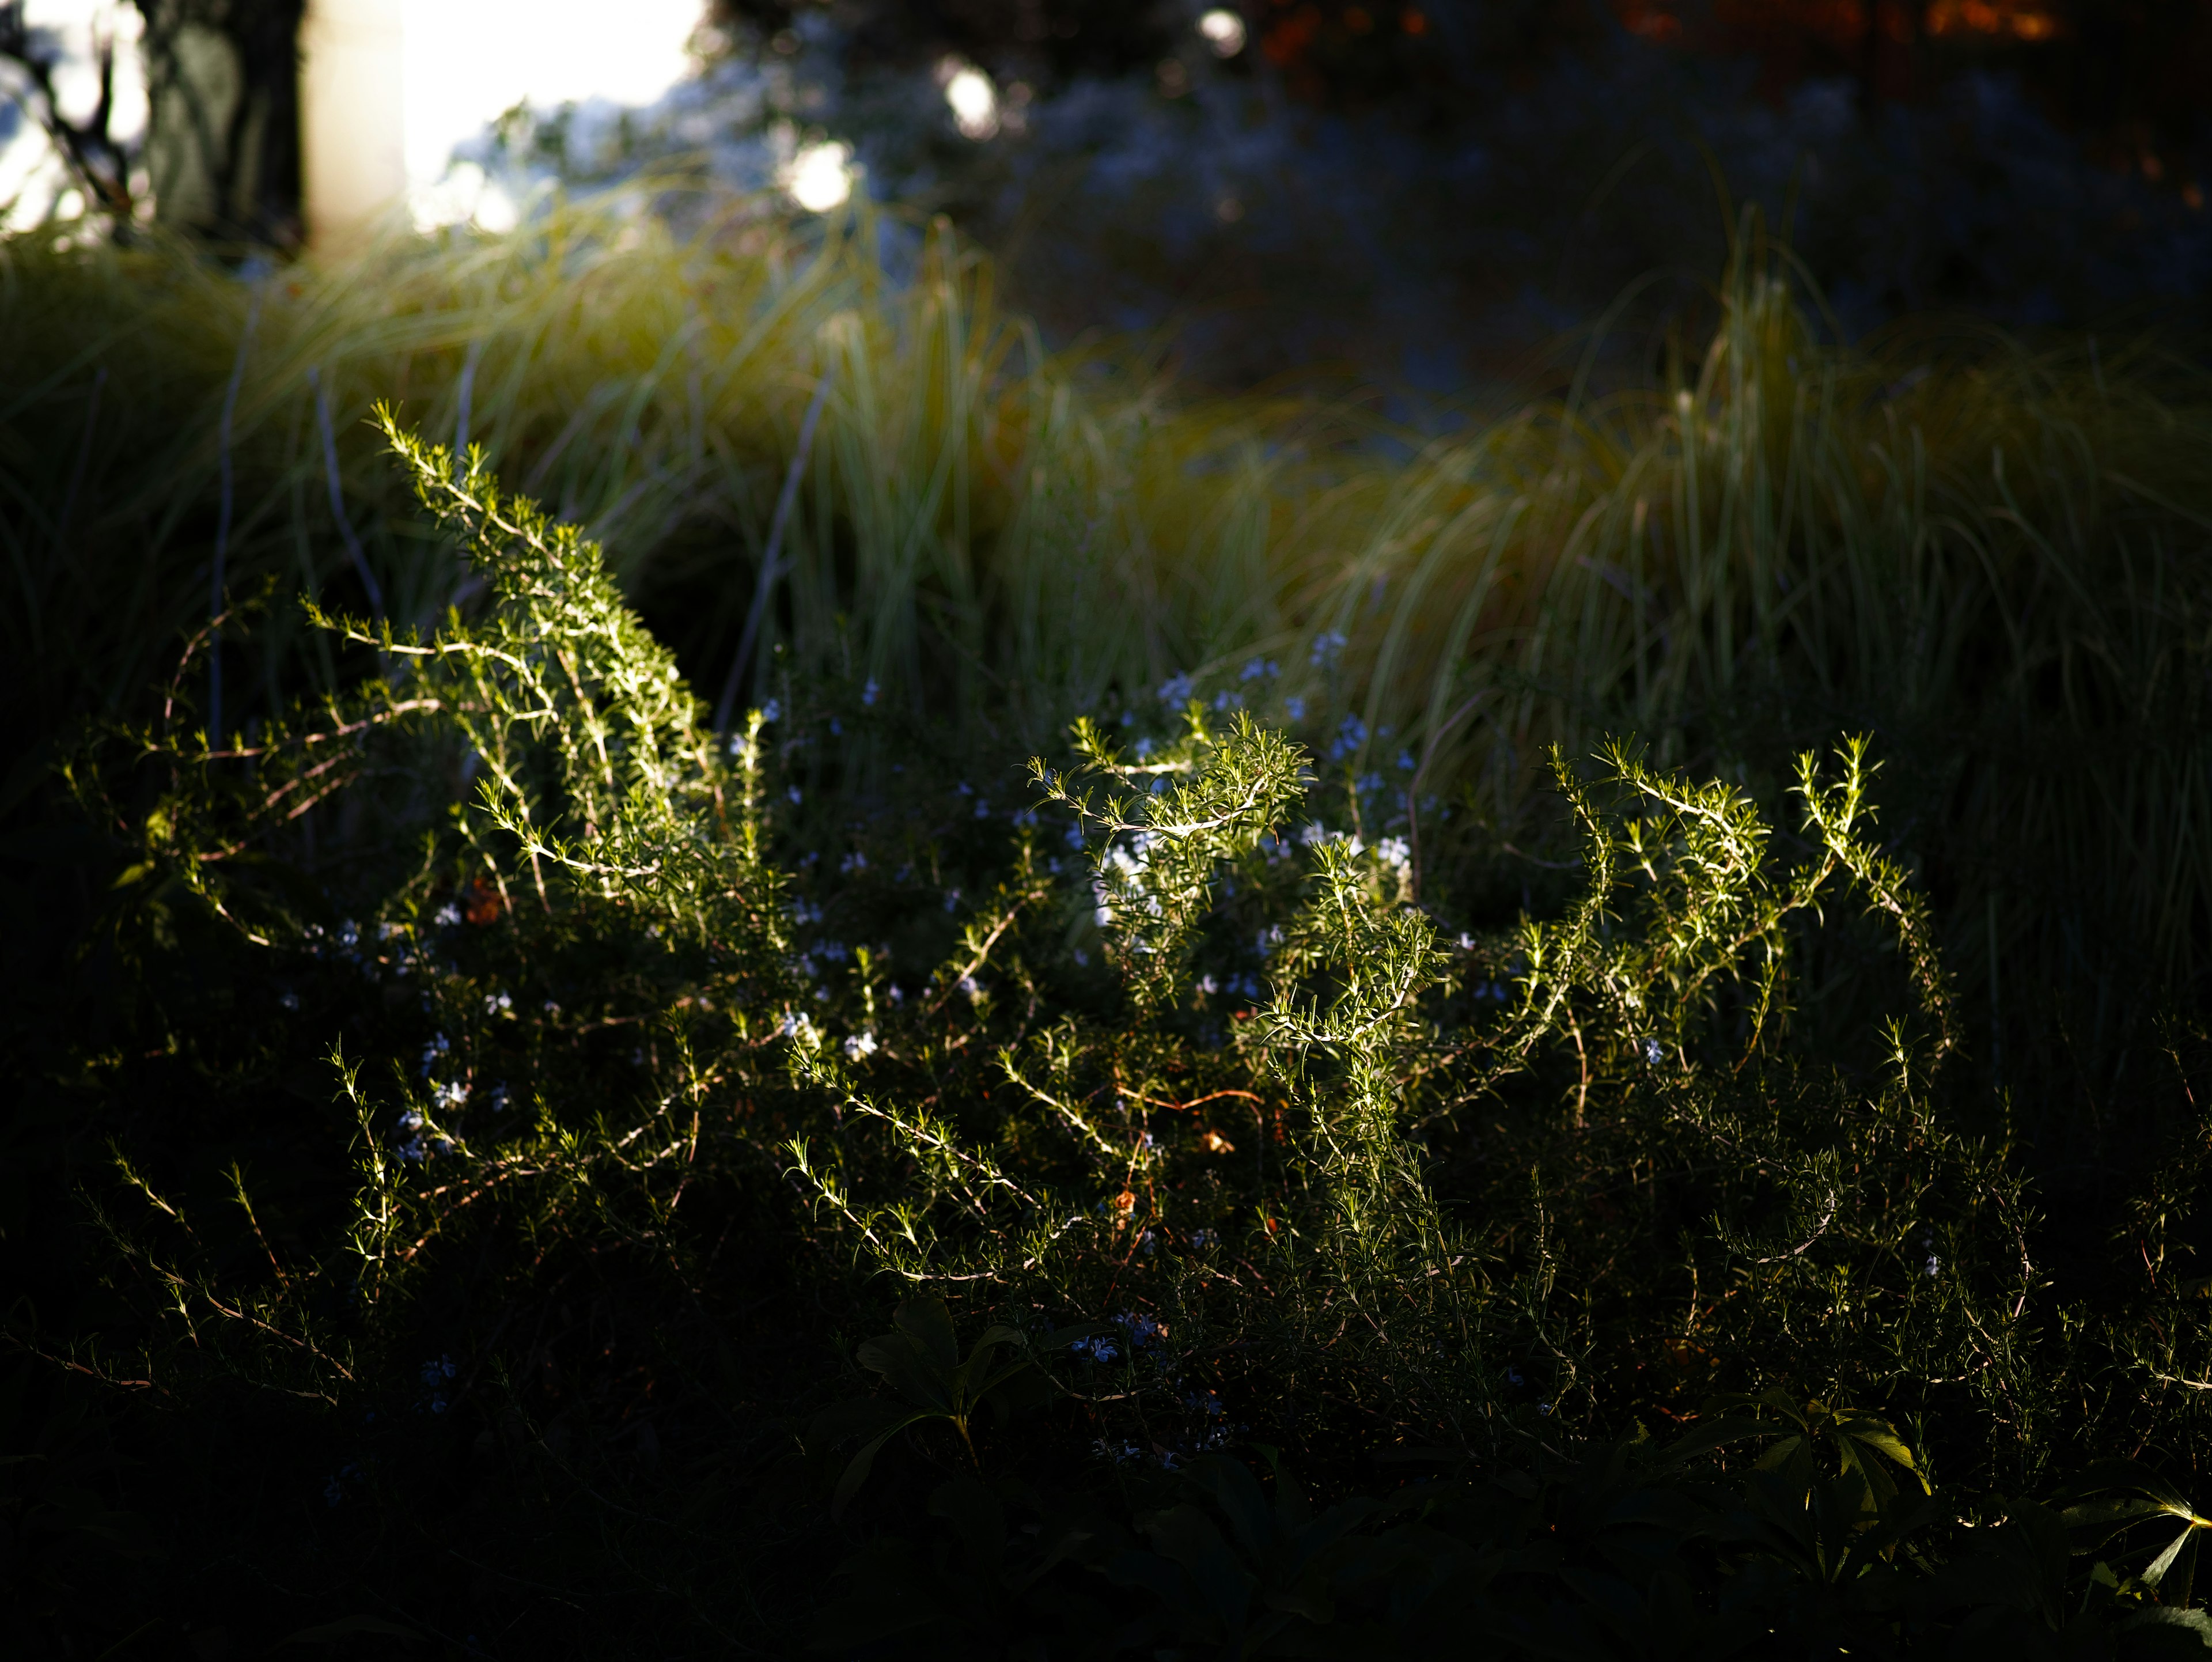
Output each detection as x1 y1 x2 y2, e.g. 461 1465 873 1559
1298 255 2212 1080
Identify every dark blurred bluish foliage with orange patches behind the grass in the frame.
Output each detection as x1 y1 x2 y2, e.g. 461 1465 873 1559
467 0 2212 389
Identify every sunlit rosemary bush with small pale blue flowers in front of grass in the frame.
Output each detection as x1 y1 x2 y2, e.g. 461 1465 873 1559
20 412 2205 1655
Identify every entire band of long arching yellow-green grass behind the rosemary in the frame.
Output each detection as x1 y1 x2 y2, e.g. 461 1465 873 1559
0 184 2212 1066
